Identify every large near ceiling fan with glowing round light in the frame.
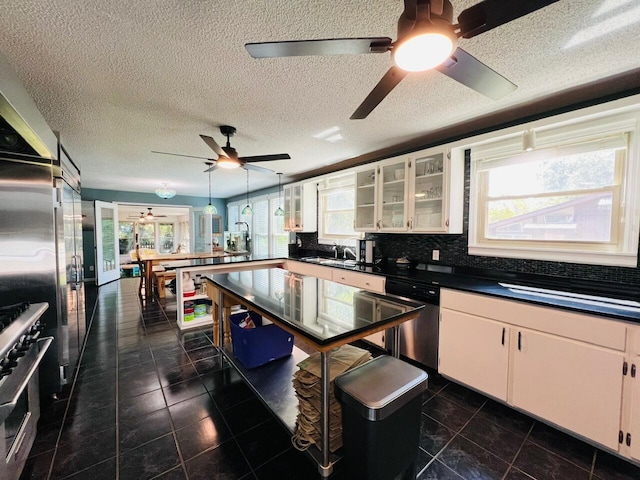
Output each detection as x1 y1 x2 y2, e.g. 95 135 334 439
245 0 558 120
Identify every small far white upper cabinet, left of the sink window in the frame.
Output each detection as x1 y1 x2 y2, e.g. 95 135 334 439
283 182 318 232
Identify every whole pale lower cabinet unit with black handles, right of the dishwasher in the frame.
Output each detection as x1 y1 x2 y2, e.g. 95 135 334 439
438 289 640 460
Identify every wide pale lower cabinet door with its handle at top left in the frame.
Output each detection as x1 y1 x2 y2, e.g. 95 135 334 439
509 329 624 450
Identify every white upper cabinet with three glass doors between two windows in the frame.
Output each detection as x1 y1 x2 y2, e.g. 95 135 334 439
355 147 464 233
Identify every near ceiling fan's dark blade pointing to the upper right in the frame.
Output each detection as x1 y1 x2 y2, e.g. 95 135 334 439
458 0 558 38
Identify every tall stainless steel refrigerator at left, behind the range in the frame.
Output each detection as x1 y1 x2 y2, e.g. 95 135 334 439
0 146 86 395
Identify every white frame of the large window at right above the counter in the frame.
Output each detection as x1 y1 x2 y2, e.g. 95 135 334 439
460 97 640 267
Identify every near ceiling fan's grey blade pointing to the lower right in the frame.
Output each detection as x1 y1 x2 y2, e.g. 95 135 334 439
436 48 518 100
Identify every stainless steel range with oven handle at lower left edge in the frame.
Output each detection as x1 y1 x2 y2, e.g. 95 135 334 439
0 302 53 480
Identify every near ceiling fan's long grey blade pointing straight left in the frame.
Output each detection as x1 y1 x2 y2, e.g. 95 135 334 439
244 37 391 58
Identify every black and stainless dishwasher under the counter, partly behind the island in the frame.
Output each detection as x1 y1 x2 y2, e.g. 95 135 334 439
385 278 440 370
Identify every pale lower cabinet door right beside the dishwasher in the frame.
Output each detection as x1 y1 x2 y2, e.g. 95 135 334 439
438 310 509 401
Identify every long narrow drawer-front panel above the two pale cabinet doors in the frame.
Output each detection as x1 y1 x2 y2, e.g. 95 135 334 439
440 289 627 351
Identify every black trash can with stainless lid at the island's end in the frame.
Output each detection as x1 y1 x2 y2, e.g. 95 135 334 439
335 355 428 480
